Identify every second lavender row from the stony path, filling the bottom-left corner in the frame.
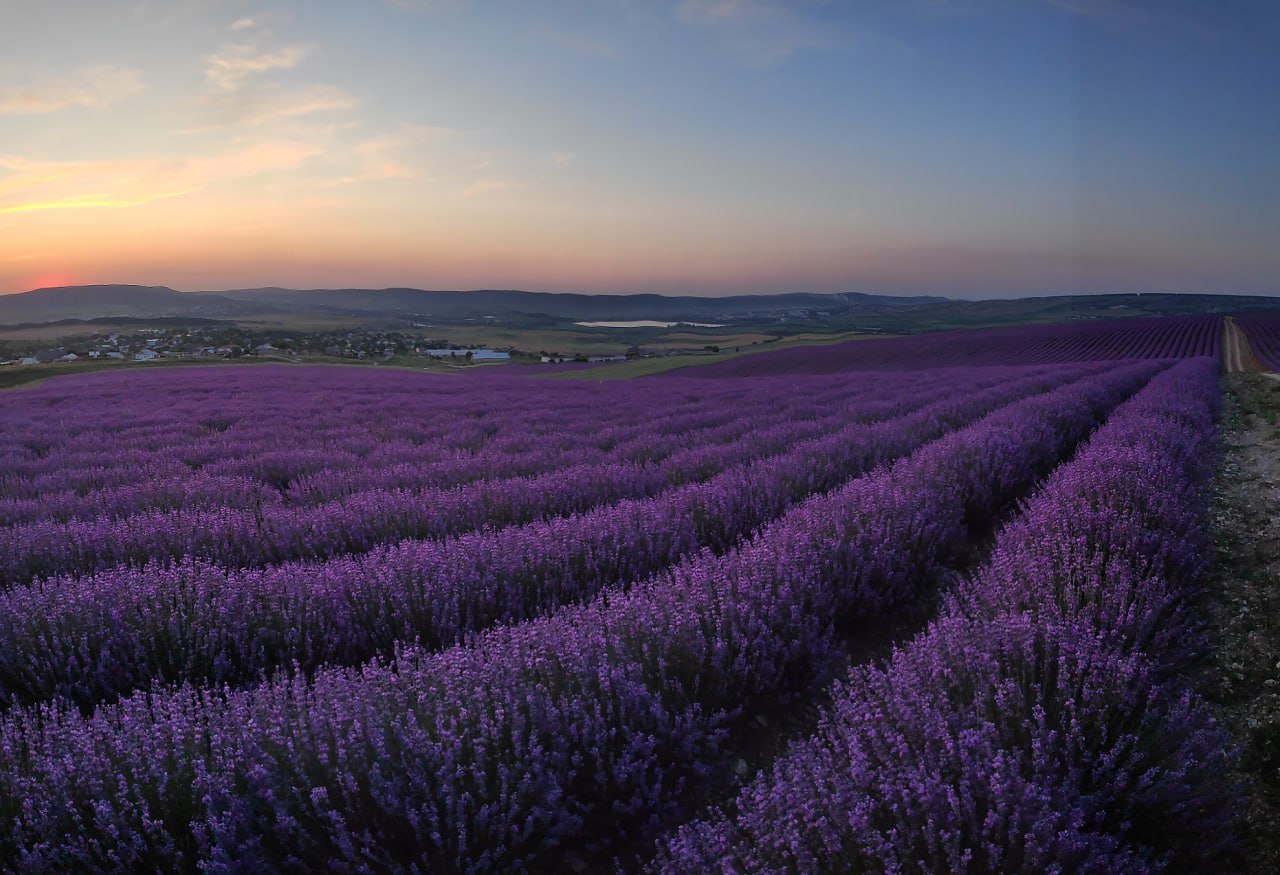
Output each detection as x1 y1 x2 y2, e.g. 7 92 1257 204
0 366 1158 872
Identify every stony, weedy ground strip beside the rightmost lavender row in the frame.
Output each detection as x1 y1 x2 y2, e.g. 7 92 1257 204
1208 374 1280 875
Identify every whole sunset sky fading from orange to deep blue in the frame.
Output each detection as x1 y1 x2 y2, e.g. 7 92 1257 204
0 0 1280 298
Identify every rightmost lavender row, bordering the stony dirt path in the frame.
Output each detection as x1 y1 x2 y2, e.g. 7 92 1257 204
654 359 1239 872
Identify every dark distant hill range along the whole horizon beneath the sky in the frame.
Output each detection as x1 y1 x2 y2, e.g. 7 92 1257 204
0 285 1280 334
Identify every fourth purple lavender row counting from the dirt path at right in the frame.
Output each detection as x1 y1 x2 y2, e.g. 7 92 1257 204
0 365 1013 585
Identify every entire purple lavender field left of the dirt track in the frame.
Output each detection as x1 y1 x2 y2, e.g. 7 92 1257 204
0 317 1239 872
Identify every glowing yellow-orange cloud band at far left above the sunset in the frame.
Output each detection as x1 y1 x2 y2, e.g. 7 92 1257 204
0 142 317 214
